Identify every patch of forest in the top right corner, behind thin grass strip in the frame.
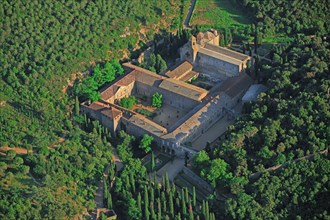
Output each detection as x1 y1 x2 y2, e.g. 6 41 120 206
235 0 330 36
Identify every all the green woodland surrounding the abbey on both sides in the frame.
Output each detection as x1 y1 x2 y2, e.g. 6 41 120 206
0 0 330 220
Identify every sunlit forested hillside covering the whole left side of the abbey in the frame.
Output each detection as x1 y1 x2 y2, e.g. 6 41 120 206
0 0 187 219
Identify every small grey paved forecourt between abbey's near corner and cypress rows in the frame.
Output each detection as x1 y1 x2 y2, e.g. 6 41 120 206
157 158 184 182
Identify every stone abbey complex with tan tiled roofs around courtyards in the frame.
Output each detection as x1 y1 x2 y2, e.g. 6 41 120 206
81 31 252 155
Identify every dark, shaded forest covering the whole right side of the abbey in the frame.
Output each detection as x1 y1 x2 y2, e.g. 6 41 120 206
192 1 330 219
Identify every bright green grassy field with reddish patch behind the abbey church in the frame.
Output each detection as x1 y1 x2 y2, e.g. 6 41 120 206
191 0 251 30
